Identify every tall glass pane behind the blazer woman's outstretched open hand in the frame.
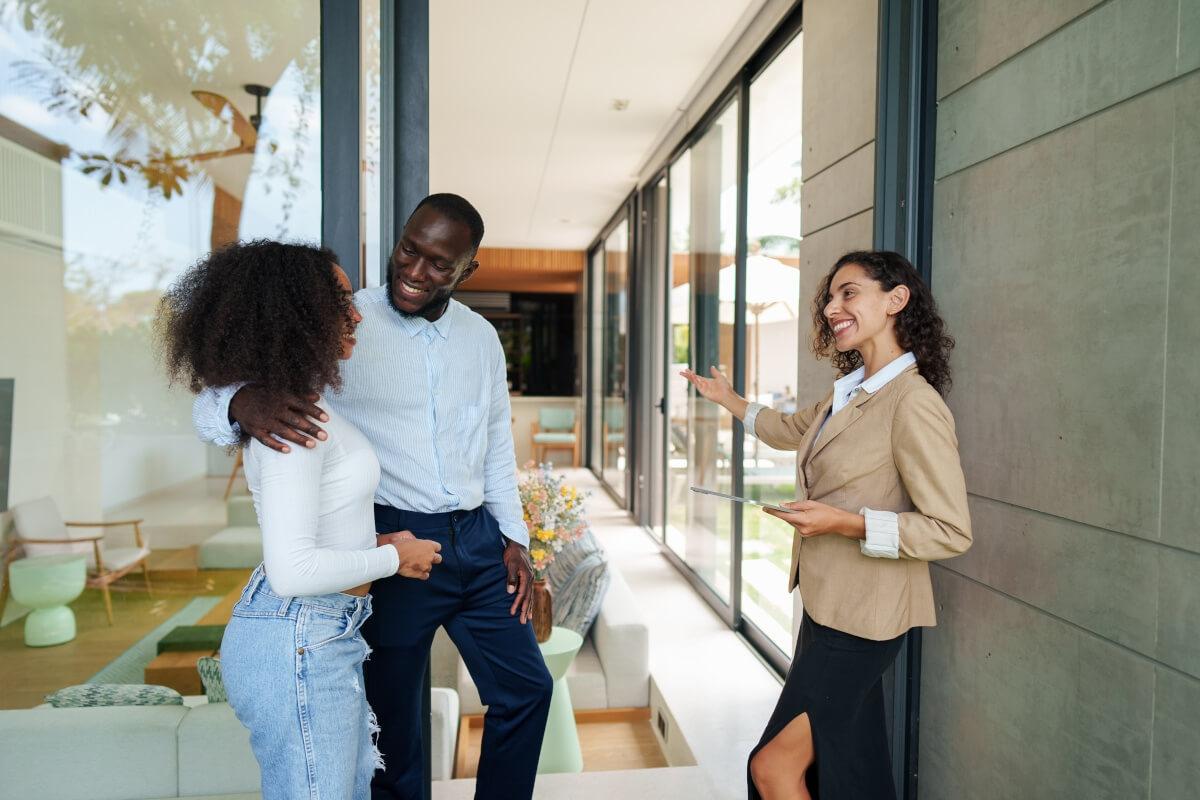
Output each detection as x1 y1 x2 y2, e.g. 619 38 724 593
666 102 738 601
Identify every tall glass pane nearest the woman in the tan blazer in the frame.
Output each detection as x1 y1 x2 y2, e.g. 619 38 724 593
736 37 804 652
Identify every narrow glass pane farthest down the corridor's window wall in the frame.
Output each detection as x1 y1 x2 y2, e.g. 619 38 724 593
599 222 629 500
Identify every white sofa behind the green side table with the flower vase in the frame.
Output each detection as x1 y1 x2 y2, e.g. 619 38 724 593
457 561 650 716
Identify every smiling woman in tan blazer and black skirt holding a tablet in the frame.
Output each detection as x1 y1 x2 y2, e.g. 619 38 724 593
683 252 971 800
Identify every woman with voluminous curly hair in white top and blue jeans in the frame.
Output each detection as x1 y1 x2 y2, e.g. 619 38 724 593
157 241 442 800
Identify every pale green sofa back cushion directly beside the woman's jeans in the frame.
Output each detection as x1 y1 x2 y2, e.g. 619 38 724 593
179 703 262 796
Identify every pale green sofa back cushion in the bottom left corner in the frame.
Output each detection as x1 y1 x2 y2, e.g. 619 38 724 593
0 705 184 800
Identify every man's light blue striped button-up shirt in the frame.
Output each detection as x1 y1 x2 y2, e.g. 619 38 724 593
193 287 529 546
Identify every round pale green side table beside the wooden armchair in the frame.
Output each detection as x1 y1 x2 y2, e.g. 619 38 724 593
8 554 88 648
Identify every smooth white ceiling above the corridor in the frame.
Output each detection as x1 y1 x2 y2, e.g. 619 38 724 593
430 0 763 249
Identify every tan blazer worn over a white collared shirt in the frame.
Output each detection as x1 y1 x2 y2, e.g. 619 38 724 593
755 367 971 640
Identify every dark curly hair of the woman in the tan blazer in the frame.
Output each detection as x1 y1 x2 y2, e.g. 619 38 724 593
812 251 954 396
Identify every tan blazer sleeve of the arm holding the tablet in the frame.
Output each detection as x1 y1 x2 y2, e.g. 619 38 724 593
892 386 971 561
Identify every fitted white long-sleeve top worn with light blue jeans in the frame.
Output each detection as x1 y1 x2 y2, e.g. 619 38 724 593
244 402 400 597
